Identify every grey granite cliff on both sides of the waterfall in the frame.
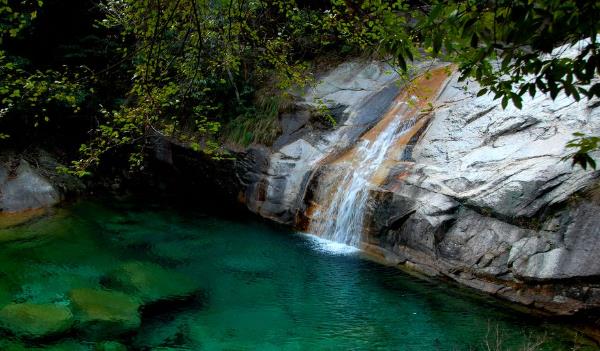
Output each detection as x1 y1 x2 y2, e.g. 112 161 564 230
238 62 600 314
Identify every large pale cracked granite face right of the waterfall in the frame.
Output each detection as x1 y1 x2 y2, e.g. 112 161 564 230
363 73 600 314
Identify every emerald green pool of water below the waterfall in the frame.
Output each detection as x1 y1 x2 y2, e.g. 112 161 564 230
0 202 596 350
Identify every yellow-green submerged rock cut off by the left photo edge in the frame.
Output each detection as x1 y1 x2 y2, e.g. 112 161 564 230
0 303 73 338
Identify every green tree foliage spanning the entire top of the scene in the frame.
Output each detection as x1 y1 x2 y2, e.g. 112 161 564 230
0 0 600 175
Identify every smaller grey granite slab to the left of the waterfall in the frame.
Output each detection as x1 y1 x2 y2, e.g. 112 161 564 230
241 61 399 224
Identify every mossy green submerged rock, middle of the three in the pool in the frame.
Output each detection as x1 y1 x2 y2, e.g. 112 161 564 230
69 288 141 337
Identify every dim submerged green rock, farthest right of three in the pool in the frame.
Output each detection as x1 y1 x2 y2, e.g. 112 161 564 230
104 262 199 304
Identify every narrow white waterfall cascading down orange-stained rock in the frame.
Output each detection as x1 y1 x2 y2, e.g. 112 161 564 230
308 69 447 247
